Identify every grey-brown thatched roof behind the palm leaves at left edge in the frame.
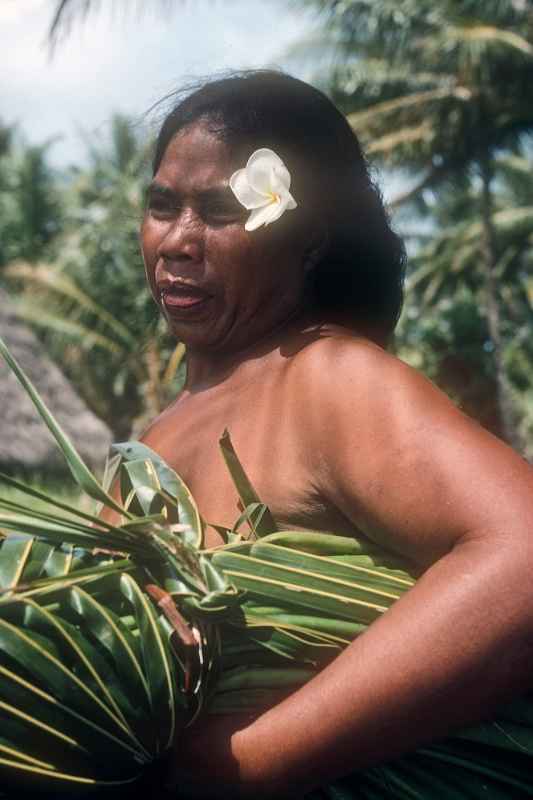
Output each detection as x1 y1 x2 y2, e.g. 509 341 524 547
0 289 111 472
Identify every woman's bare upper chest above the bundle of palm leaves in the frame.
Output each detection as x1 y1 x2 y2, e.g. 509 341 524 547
139 386 352 546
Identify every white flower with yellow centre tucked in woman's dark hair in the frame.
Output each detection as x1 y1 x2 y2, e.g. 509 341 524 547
229 147 297 231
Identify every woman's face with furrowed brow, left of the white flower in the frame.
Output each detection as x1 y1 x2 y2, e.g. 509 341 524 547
141 122 304 351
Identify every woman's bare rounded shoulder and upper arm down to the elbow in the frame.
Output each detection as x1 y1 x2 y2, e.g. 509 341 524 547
286 324 533 565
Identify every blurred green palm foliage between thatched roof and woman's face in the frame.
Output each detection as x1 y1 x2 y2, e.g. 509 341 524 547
0 116 184 439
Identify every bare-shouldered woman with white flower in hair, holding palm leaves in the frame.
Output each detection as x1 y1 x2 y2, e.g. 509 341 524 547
141 72 533 798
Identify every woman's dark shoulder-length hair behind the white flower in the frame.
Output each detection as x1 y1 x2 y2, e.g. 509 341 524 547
153 70 405 341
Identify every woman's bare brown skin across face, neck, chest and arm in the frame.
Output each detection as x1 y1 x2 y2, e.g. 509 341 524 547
136 123 533 798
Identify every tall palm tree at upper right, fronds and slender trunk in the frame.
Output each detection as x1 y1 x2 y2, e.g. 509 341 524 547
298 0 533 444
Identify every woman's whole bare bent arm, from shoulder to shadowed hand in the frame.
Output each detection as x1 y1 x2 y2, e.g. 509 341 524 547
166 340 533 797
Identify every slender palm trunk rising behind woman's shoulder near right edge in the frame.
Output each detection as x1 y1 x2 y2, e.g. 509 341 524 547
479 152 523 452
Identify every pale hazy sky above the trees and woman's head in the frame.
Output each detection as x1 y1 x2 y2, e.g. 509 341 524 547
0 0 313 167
